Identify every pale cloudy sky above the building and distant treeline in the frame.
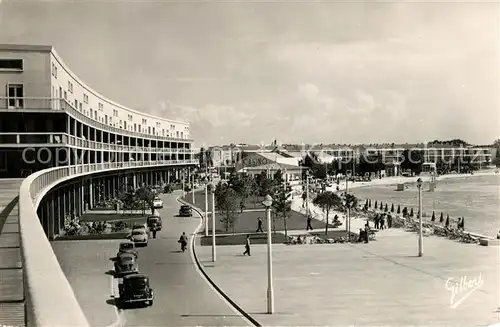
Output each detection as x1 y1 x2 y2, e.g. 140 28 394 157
0 0 500 145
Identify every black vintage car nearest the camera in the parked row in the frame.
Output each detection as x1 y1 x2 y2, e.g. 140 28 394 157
118 274 154 307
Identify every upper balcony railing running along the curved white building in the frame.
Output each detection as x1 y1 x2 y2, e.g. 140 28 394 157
0 97 193 142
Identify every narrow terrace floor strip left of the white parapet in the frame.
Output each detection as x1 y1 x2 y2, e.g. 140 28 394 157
0 179 25 327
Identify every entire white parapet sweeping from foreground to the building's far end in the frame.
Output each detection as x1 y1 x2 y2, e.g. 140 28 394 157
19 160 197 327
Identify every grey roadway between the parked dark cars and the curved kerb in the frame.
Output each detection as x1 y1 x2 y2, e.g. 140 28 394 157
119 192 248 326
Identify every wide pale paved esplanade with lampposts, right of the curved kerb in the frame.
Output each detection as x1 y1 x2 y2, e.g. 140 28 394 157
196 229 500 326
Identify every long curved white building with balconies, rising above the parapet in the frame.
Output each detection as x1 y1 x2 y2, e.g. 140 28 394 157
0 45 196 178
